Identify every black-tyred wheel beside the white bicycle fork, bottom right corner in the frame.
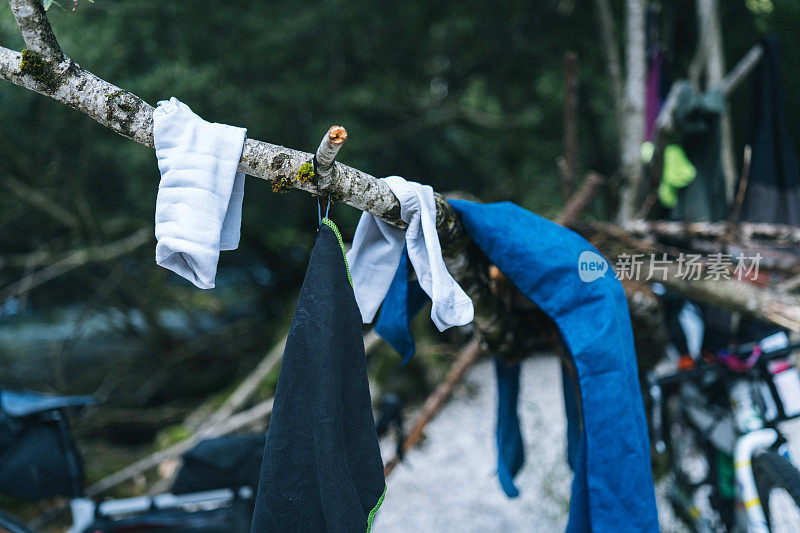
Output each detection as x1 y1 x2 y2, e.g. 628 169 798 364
753 452 800 533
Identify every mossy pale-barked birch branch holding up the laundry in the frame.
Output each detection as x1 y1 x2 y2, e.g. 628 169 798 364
0 0 520 352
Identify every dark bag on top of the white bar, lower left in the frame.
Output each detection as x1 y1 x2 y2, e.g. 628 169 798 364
171 433 265 494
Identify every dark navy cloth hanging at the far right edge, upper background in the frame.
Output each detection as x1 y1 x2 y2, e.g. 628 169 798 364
740 36 800 226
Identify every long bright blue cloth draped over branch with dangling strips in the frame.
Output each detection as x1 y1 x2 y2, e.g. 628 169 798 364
382 201 658 533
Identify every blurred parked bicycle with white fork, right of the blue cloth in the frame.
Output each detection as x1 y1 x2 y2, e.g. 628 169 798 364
647 334 800 533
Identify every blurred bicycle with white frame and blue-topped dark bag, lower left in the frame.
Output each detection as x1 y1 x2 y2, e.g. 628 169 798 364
0 391 255 533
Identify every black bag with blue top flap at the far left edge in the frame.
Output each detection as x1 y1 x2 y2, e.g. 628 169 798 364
0 391 94 500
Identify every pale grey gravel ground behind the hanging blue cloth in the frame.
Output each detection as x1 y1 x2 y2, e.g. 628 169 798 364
373 356 800 533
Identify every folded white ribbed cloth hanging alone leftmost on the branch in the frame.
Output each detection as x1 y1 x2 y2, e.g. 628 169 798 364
153 97 247 289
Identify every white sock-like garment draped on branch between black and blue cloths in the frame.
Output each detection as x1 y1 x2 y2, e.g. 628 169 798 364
347 176 474 331
